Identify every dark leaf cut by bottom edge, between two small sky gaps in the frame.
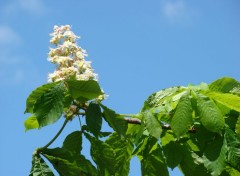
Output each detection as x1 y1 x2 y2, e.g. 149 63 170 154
141 144 169 176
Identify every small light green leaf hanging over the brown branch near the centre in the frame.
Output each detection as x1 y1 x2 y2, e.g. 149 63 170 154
143 112 162 139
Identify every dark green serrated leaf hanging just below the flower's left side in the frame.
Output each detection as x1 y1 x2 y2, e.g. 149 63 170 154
33 82 65 128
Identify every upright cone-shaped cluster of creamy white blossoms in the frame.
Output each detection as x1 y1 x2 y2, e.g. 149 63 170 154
48 25 98 82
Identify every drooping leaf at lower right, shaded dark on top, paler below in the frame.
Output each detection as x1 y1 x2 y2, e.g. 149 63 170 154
202 136 227 176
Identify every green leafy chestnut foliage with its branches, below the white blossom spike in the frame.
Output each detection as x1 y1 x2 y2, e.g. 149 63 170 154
24 77 240 176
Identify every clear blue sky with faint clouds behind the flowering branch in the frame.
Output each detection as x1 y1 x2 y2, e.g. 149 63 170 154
0 0 240 176
